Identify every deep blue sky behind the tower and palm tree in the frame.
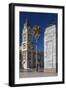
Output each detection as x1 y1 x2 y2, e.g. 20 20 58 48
19 12 58 51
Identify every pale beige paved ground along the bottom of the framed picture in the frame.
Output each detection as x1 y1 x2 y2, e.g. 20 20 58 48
19 71 57 78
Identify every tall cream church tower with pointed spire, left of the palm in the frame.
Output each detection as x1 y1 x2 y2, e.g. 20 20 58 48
21 20 33 69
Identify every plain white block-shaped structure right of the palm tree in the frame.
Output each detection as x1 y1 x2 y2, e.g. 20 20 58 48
44 25 56 71
